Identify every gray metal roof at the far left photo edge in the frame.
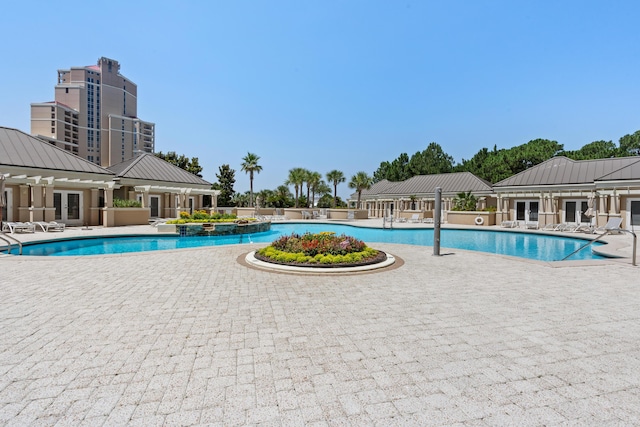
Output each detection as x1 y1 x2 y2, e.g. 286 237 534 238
0 126 113 176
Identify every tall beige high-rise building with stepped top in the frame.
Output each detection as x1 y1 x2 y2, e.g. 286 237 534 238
31 57 155 167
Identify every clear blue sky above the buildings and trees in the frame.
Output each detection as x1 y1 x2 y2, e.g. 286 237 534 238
0 0 640 198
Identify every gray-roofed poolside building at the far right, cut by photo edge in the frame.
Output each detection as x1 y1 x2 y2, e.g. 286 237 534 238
493 156 640 227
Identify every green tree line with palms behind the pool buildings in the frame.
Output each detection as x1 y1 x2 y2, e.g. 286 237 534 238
156 130 640 208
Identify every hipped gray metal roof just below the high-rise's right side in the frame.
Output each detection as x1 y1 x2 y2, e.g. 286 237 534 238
108 153 211 186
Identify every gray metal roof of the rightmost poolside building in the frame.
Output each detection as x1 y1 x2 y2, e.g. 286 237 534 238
493 156 640 187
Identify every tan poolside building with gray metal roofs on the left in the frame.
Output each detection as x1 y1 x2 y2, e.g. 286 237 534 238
0 127 218 226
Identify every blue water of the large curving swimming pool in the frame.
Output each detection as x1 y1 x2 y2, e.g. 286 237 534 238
14 223 603 261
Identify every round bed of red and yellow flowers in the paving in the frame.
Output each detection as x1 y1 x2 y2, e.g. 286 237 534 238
254 231 387 267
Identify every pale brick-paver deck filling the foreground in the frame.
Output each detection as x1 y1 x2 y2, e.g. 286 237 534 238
0 226 640 426
